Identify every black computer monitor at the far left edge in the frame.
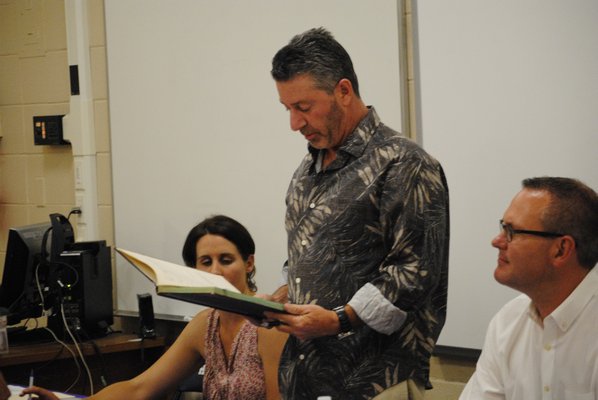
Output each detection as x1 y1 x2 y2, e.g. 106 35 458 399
0 223 51 325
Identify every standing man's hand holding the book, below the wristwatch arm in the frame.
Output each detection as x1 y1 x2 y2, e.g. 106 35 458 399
264 304 340 340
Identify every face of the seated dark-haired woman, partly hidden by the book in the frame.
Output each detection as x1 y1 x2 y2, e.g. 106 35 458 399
195 234 254 293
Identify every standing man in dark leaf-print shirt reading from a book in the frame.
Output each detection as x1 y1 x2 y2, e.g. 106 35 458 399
268 28 449 400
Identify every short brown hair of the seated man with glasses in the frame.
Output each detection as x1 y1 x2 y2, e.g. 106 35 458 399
522 177 598 269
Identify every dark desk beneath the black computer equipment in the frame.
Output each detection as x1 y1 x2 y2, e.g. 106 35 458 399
0 334 164 395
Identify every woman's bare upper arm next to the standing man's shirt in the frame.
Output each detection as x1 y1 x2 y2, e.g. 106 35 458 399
257 328 289 400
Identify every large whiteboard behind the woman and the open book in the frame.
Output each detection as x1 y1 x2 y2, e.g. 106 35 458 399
105 0 402 317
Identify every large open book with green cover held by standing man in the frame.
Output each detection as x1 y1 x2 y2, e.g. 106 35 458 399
116 248 285 320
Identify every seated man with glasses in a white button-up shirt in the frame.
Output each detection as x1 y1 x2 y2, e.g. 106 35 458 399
460 177 598 400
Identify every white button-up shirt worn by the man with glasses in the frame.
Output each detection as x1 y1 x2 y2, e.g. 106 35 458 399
459 267 598 400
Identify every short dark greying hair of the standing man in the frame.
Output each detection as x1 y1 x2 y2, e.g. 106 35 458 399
271 28 359 97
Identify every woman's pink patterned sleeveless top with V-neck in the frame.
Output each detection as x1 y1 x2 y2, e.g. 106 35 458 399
203 310 266 400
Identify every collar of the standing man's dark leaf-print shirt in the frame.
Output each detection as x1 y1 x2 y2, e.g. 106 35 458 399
307 106 380 170
